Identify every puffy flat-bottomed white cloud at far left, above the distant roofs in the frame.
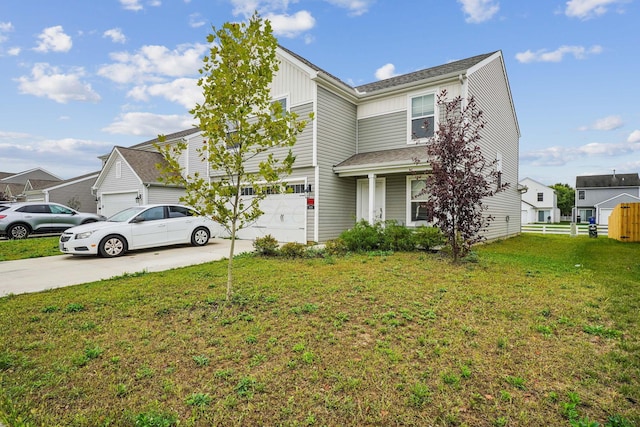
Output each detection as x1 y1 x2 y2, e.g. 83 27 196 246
17 63 100 104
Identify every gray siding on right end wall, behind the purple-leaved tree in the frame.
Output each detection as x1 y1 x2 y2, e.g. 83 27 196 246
468 57 521 239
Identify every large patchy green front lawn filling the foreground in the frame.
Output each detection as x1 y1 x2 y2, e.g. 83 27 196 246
0 235 640 426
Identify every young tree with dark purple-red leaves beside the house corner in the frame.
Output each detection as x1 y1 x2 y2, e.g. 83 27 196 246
425 90 509 262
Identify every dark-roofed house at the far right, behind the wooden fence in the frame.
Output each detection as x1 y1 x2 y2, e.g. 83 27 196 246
574 173 640 225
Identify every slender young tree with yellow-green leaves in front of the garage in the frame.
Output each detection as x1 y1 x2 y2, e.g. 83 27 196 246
158 13 313 301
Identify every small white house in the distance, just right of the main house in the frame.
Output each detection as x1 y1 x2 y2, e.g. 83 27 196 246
519 178 560 224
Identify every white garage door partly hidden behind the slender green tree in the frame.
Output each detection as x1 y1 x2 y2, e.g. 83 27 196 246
238 194 307 243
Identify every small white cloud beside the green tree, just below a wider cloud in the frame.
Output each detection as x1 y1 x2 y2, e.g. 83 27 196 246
127 78 204 110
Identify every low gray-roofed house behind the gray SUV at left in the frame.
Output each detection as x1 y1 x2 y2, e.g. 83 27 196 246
23 172 99 213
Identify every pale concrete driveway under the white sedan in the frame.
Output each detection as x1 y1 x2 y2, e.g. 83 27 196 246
0 238 253 297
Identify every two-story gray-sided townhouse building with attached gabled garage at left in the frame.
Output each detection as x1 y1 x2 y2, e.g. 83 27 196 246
94 47 521 243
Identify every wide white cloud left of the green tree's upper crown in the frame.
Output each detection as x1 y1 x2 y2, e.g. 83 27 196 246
98 44 208 83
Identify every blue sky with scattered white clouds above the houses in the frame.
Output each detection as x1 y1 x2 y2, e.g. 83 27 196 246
0 0 640 186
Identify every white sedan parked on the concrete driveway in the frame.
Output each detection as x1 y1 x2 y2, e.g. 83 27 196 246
60 205 217 257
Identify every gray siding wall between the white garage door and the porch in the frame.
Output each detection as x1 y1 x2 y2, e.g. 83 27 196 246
315 87 356 242
